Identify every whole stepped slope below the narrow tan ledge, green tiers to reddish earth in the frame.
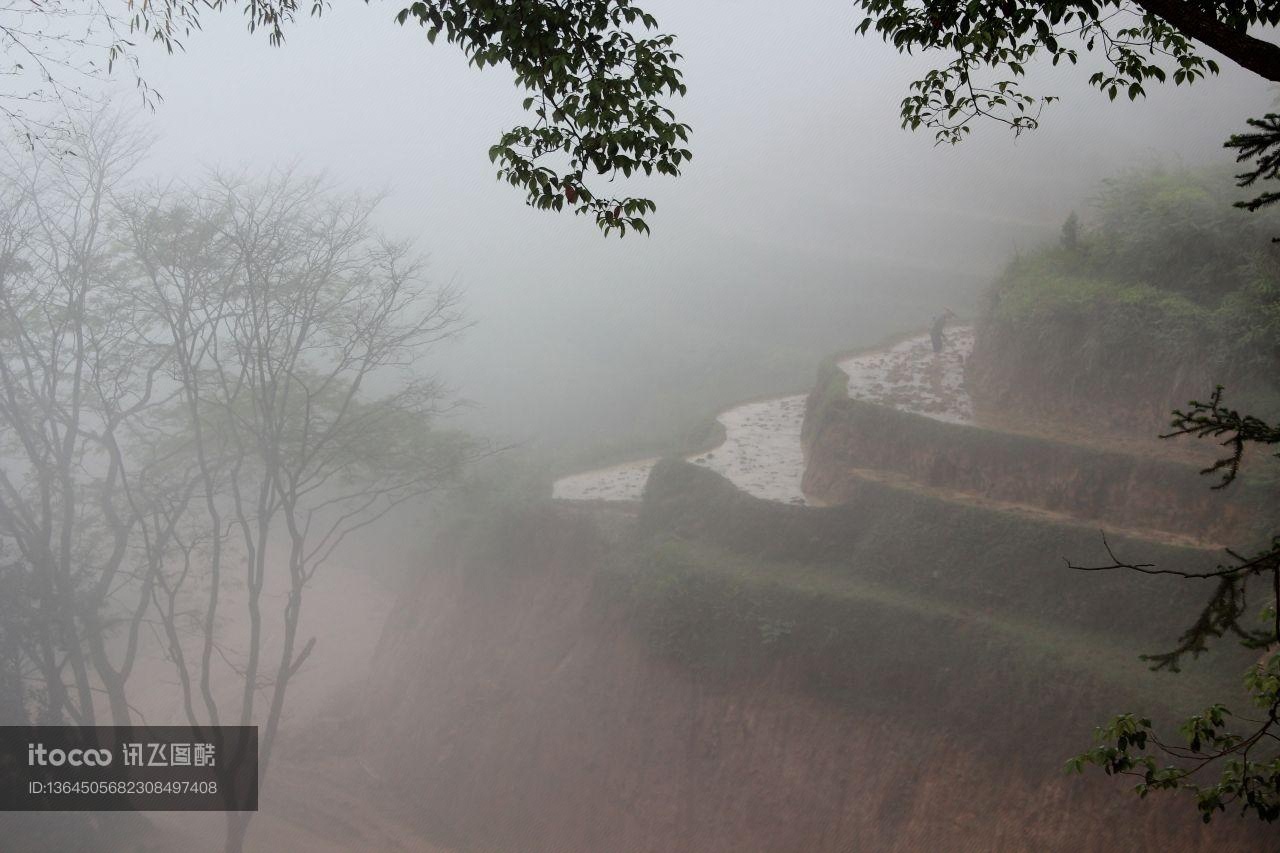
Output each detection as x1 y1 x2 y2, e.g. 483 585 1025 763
366 484 1268 853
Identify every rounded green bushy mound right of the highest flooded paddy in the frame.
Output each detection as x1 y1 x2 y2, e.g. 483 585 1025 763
986 169 1280 421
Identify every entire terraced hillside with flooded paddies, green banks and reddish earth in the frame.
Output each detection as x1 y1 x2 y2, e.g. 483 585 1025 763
353 302 1274 852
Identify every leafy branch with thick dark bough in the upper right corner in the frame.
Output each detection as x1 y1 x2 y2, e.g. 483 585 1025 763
858 0 1280 143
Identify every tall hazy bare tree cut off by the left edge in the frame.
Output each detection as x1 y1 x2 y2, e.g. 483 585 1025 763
0 114 163 725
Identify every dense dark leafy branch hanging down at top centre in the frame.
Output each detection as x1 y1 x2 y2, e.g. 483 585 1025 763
129 0 692 234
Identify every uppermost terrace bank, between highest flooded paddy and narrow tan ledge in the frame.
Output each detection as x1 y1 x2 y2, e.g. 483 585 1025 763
804 350 1280 544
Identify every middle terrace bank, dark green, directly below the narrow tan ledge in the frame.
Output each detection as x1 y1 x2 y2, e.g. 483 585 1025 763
640 461 1244 685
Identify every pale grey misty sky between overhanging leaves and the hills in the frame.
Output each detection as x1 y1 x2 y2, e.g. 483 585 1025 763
102 0 1274 450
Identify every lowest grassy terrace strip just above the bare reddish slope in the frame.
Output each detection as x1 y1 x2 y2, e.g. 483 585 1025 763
605 538 1249 771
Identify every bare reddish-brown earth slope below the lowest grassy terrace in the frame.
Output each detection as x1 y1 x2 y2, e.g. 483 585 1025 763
366 502 1266 853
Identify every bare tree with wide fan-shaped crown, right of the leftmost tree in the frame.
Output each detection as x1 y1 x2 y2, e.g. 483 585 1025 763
124 173 472 850
